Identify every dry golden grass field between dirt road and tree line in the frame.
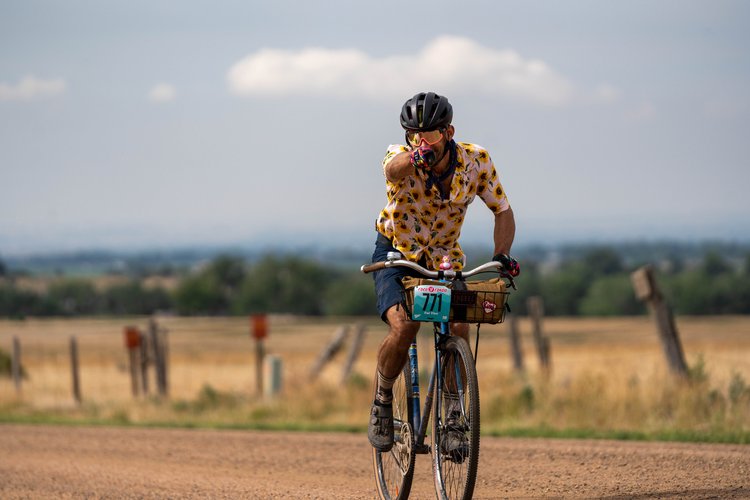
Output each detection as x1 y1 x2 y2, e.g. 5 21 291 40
0 316 750 442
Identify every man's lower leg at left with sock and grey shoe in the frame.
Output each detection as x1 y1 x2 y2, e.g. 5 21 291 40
367 304 419 451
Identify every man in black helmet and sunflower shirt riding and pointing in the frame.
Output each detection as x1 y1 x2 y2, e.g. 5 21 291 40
368 92 520 451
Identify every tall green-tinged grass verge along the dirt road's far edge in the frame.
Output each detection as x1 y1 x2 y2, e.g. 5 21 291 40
0 358 750 444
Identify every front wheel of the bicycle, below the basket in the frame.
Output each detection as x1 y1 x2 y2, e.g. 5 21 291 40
432 337 479 500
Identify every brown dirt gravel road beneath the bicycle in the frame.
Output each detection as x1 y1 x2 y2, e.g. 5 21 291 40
0 425 750 499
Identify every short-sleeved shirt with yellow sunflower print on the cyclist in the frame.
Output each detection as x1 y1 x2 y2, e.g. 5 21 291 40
375 142 510 270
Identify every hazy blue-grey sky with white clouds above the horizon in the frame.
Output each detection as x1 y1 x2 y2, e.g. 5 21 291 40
0 0 750 254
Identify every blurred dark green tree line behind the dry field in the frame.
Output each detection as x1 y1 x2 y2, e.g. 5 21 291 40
0 247 750 318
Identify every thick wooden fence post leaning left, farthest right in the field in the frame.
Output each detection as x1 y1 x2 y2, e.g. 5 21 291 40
630 265 688 378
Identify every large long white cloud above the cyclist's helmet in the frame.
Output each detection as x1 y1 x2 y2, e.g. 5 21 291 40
227 36 573 106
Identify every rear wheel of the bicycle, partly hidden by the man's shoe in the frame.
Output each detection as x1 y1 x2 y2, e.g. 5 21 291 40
372 365 415 500
